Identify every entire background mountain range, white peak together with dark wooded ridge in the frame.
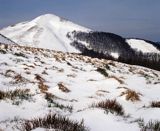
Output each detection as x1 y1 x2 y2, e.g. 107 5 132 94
0 14 160 70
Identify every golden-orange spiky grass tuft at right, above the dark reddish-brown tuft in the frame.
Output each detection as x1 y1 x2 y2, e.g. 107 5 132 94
120 89 142 102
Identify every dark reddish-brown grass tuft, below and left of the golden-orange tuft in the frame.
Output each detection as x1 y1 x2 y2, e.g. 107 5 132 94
92 99 124 115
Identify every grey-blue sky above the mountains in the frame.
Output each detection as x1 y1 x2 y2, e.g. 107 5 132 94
0 0 160 41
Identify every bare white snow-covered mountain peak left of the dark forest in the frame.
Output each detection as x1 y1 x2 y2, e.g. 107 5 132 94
0 14 89 52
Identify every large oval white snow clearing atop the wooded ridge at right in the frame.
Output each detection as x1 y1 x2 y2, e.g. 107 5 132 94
126 39 160 53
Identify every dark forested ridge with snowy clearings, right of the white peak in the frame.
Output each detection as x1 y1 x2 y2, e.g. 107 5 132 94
68 31 160 70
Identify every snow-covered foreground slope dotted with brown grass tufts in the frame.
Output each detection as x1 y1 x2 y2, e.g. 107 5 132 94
0 44 160 131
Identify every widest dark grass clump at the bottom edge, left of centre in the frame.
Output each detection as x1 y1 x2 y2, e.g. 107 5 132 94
22 114 88 131
